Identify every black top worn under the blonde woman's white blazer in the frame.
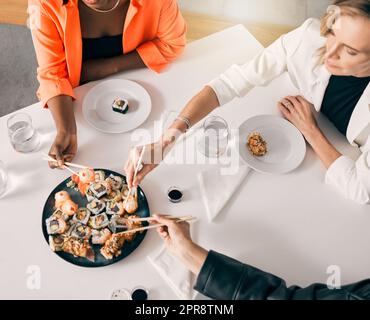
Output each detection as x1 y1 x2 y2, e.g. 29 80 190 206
321 76 370 135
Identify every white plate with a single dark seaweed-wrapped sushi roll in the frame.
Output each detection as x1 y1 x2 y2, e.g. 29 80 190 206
82 79 152 133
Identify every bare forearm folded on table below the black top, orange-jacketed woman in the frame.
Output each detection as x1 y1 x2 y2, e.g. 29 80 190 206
81 51 146 83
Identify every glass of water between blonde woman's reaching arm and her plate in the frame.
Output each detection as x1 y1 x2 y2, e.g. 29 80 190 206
198 116 230 158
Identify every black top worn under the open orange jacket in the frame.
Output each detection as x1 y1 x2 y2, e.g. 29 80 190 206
82 34 123 61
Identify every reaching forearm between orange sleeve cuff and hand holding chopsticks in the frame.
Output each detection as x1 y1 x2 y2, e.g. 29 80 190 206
48 95 77 134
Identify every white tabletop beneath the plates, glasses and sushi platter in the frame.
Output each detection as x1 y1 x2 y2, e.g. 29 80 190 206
0 26 370 299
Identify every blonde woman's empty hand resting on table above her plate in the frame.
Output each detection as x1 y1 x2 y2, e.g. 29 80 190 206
278 96 319 139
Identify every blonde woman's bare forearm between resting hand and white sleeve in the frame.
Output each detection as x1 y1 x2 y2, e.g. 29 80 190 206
305 128 342 169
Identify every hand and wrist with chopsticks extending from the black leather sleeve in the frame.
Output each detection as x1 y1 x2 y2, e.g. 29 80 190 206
153 215 208 276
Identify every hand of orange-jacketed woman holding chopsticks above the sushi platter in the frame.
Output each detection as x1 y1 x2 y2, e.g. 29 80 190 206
49 132 77 169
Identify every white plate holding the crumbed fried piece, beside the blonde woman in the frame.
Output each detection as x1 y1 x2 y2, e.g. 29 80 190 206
239 115 306 174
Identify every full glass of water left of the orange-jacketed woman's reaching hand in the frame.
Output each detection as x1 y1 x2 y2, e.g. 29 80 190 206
8 113 40 153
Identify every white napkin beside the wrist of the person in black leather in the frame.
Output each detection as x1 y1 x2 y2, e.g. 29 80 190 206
147 246 196 300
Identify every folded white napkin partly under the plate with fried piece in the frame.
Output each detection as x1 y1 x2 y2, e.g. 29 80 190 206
198 165 251 222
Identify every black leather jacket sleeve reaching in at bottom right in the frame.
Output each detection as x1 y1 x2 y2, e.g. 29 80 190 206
195 251 370 300
